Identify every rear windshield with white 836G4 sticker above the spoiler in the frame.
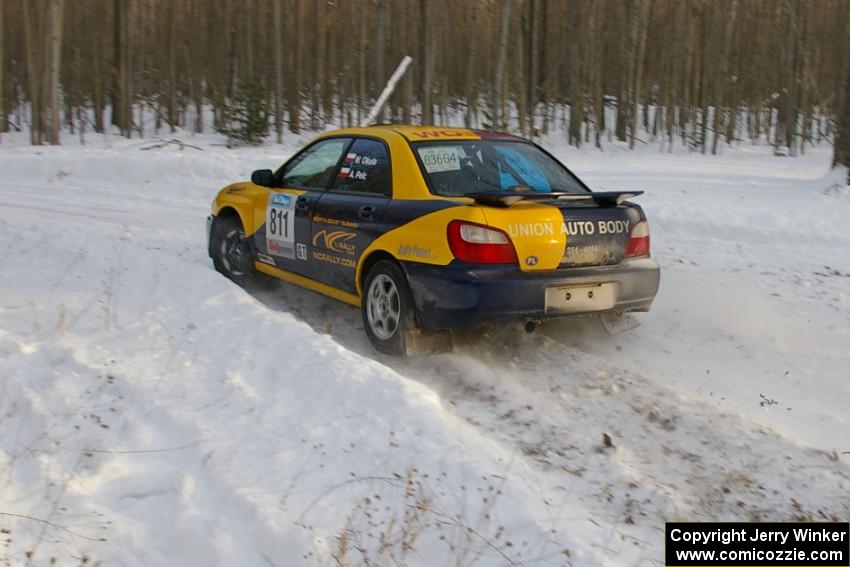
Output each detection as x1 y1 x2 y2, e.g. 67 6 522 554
412 140 587 197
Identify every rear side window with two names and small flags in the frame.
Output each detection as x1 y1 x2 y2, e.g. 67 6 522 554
331 138 390 195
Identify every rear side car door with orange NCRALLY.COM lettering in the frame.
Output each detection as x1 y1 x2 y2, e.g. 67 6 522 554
310 138 392 293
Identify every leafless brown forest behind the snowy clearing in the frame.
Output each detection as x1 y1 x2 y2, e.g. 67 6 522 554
0 0 850 162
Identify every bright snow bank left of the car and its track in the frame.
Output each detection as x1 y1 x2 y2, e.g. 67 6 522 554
0 143 584 565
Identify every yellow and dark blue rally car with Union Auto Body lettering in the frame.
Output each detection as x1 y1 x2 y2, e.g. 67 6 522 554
208 125 659 354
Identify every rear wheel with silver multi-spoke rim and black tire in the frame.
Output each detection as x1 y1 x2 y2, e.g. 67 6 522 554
360 260 416 356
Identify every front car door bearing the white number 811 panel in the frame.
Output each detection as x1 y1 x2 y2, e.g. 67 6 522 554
254 138 352 275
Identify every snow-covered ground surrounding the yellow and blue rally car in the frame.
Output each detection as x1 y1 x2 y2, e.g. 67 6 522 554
0 129 850 566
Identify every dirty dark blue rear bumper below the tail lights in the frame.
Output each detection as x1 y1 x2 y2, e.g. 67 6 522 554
402 258 660 329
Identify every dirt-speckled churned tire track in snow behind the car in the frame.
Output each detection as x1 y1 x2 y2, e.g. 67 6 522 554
251 282 850 556
